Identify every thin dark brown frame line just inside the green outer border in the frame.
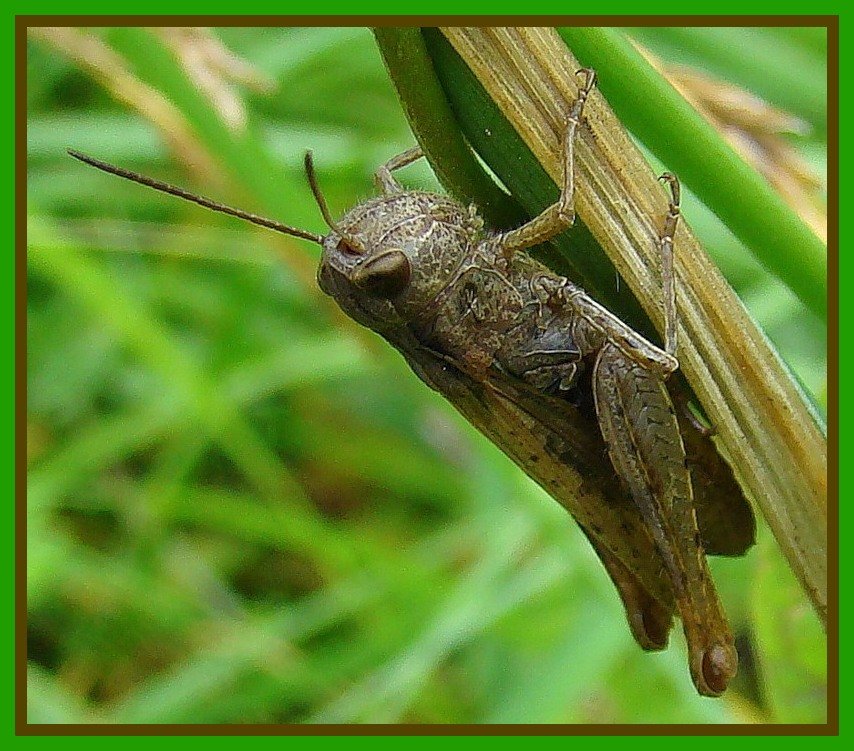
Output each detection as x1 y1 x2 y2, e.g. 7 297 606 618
15 15 839 736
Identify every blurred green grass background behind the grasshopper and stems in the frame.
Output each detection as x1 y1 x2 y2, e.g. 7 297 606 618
27 28 826 723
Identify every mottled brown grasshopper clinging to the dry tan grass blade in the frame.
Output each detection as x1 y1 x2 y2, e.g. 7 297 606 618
70 70 753 696
